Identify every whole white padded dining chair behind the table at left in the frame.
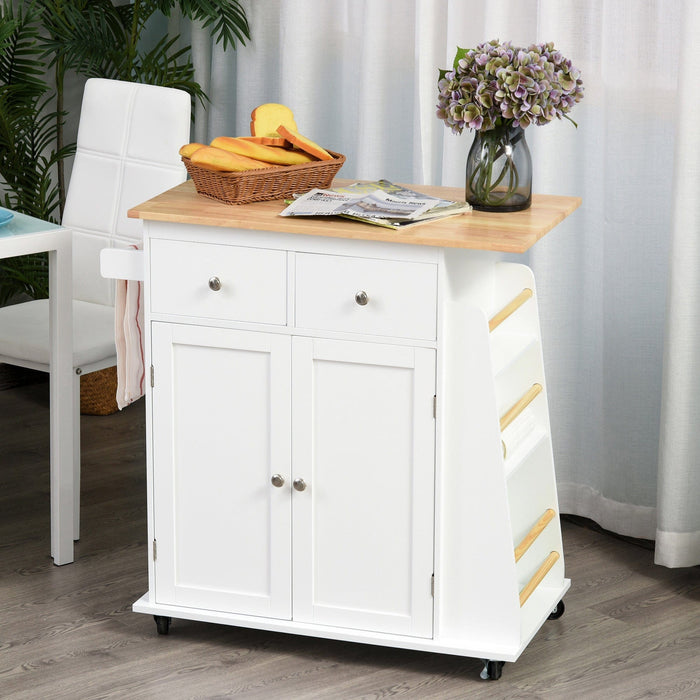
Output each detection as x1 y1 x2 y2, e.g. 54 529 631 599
0 78 191 540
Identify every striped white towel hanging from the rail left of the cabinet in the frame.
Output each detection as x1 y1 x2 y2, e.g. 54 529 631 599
114 258 145 410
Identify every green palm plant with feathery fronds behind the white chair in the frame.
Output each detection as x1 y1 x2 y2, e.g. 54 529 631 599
0 0 250 304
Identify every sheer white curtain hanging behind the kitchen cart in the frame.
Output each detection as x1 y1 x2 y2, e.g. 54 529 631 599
186 0 700 566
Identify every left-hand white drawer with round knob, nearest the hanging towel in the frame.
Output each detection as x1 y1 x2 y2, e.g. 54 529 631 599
151 239 287 325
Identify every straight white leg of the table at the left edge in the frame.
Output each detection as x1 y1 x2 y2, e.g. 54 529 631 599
49 231 74 565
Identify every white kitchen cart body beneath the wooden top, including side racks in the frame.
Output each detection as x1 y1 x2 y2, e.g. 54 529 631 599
129 212 569 672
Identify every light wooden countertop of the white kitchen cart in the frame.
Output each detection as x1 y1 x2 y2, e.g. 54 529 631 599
128 179 581 253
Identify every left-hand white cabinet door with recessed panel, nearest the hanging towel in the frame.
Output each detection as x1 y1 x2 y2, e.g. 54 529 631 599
152 323 291 618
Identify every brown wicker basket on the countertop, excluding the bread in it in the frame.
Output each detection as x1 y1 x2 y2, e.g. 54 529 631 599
182 151 345 204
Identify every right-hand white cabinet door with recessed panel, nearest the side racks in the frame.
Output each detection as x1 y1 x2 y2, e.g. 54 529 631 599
292 338 435 637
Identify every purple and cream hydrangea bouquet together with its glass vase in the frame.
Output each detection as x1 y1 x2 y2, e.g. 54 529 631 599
437 40 583 211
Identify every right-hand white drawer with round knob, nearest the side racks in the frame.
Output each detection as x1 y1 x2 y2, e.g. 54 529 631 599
295 253 437 340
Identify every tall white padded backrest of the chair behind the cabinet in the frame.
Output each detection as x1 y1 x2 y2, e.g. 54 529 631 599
62 78 190 306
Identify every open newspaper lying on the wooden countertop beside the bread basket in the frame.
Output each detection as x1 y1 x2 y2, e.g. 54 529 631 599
281 188 435 221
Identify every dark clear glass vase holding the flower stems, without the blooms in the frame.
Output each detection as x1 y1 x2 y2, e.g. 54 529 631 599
465 124 532 212
